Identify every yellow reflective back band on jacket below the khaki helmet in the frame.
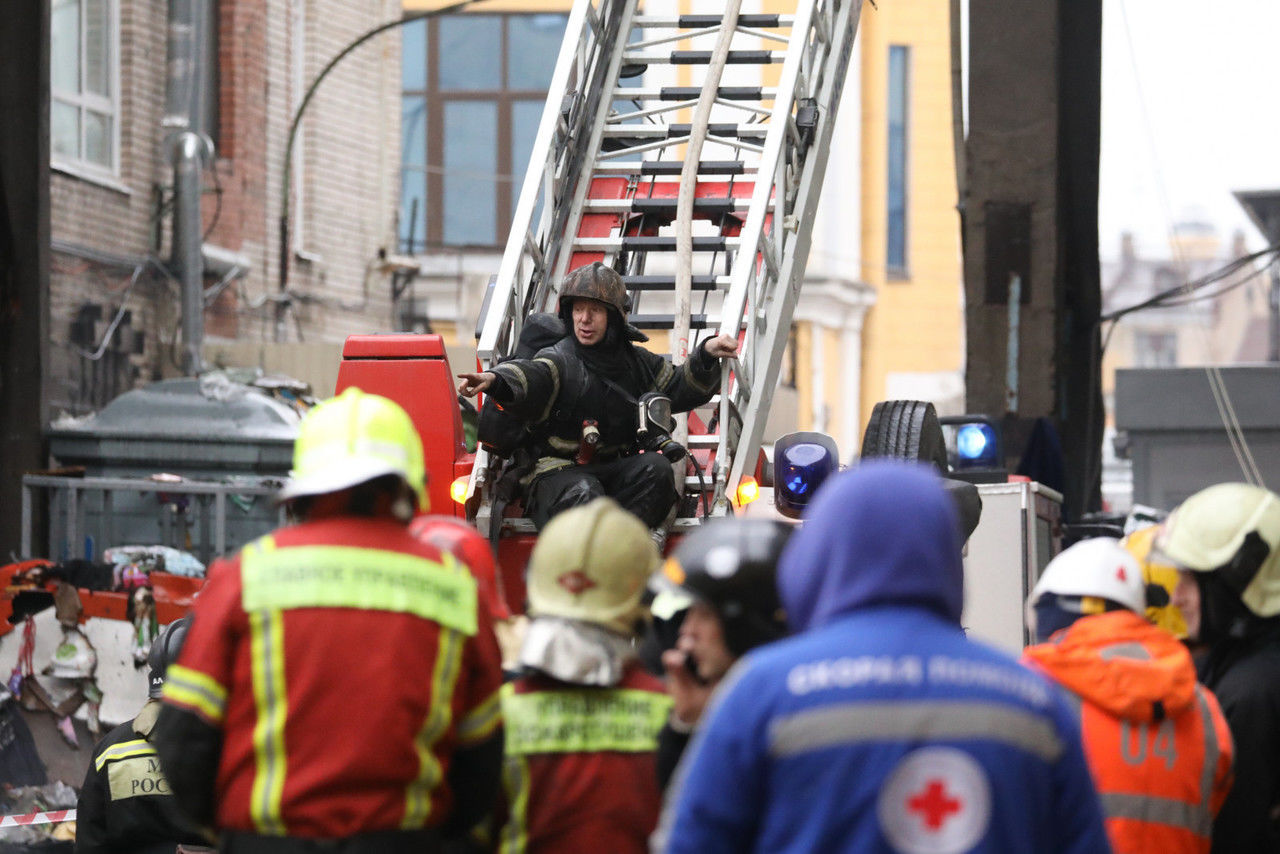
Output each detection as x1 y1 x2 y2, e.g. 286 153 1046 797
502 685 671 755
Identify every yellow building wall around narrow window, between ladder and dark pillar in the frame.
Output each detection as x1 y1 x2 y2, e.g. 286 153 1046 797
858 0 964 430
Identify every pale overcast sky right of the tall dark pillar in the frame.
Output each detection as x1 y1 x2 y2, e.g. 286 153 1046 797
1098 0 1280 257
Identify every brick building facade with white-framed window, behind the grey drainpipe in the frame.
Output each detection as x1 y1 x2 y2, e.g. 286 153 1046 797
45 0 401 416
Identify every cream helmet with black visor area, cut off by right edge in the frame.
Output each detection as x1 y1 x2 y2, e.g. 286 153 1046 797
1156 483 1280 617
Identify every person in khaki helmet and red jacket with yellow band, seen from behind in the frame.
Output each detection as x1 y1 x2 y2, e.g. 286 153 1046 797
498 498 671 854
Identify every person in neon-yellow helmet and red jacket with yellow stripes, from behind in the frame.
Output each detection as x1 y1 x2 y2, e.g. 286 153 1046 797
154 389 502 854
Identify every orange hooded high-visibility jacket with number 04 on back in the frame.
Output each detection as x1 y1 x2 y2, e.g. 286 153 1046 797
1025 611 1233 854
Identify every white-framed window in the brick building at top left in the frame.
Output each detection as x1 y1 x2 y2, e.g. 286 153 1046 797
49 0 120 174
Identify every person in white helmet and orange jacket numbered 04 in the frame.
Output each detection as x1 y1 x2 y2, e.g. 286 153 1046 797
1025 538 1233 854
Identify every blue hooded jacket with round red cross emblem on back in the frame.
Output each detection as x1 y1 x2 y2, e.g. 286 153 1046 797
653 460 1110 854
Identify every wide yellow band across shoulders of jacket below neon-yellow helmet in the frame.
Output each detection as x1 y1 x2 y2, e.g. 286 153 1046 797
241 545 476 635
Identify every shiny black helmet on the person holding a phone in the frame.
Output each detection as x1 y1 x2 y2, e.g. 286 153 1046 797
663 519 791 656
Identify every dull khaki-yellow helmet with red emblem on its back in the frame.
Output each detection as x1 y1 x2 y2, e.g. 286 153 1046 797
529 498 658 635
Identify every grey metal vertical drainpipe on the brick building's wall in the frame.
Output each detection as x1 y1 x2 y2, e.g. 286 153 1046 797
163 0 207 375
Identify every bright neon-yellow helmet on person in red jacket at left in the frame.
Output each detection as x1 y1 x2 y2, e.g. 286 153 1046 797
279 387 429 511
